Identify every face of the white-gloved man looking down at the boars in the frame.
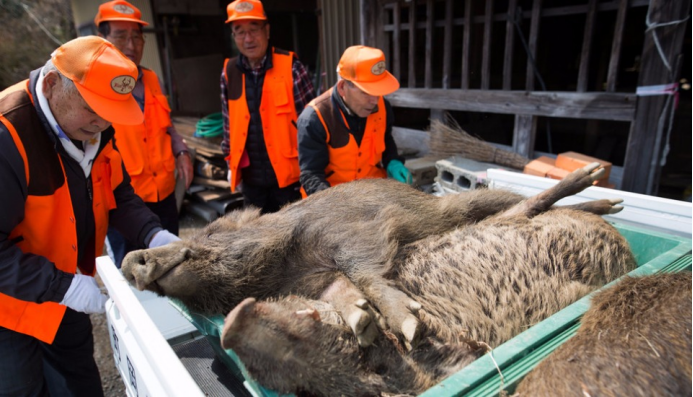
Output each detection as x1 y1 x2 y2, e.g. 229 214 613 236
42 71 111 141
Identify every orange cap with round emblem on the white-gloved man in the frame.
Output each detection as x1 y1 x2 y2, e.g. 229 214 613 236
51 36 144 125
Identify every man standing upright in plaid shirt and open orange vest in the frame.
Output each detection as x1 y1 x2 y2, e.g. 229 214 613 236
221 0 315 213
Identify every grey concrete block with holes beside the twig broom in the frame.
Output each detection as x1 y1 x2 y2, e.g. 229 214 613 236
436 157 504 192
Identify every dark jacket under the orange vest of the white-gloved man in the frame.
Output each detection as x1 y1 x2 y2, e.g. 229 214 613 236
0 70 161 303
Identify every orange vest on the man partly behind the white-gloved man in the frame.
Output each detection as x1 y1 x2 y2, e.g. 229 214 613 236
113 68 176 203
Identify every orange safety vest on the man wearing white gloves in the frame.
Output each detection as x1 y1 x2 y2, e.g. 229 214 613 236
0 80 123 343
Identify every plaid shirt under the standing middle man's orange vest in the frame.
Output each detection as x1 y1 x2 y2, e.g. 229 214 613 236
220 50 315 156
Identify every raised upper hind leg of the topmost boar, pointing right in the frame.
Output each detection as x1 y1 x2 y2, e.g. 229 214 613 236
499 162 606 218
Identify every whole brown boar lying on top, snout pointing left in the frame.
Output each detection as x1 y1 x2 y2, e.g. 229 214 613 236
123 163 619 347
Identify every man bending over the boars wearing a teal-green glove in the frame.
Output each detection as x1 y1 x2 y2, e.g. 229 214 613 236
298 46 411 195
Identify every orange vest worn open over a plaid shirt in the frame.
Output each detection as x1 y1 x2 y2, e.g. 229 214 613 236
224 48 301 192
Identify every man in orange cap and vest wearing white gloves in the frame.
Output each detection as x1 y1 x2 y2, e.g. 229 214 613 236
0 36 179 397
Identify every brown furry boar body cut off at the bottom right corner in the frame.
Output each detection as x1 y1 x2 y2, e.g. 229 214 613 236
516 272 693 397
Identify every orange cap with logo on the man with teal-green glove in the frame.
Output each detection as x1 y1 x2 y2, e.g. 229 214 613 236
337 45 399 96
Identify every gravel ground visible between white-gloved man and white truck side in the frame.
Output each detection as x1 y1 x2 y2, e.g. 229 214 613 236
91 209 206 397
